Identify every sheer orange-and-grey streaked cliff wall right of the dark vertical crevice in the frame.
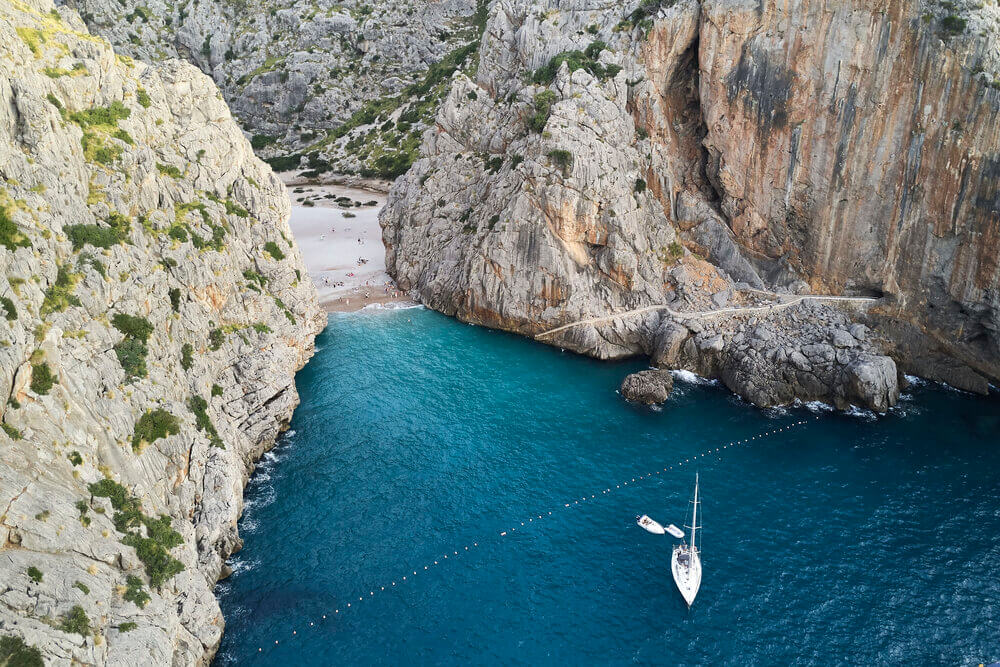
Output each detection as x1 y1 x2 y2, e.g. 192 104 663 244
699 0 1000 394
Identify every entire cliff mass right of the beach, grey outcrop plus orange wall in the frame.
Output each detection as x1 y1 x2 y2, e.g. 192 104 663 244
382 0 1000 410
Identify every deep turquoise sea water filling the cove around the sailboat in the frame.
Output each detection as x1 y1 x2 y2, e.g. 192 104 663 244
216 309 1000 665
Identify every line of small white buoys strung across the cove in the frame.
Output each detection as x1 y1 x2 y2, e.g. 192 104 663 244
246 416 819 655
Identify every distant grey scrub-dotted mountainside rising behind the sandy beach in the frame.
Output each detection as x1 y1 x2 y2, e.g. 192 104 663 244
68 0 479 177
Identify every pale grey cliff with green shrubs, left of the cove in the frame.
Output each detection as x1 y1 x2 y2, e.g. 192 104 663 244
0 0 324 665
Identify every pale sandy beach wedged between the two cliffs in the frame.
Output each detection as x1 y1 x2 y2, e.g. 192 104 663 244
286 179 411 312
